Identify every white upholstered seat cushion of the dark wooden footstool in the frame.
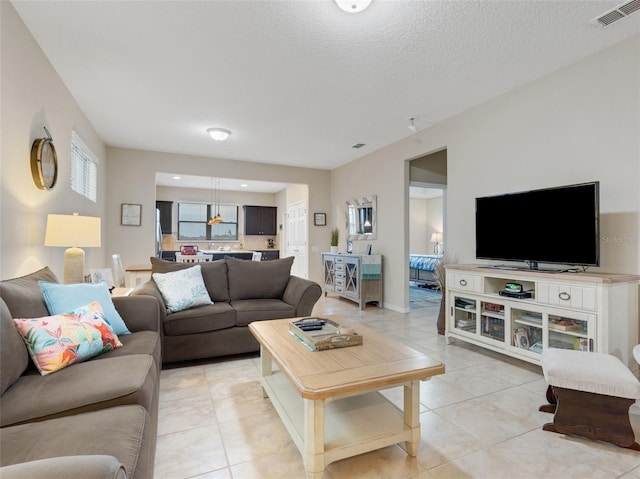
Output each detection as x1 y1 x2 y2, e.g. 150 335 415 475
542 348 640 399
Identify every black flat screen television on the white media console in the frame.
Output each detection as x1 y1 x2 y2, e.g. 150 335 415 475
476 181 600 269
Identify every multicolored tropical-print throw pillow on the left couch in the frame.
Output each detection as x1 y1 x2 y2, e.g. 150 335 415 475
13 301 122 376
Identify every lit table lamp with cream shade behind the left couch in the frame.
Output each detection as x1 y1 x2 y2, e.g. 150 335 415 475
44 213 100 284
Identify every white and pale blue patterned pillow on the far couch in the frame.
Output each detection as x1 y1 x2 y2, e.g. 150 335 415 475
152 265 213 313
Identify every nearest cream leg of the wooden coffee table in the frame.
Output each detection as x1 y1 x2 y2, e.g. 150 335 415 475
303 399 324 479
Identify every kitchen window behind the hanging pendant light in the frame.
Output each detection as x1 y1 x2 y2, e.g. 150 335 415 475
178 203 238 241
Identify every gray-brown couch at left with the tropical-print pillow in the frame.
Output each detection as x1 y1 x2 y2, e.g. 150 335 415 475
0 268 161 479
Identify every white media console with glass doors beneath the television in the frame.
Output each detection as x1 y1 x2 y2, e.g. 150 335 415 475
446 264 640 373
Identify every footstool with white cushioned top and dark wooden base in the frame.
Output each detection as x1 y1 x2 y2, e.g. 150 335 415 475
540 348 640 451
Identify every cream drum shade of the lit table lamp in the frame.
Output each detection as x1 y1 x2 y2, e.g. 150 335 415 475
44 214 101 248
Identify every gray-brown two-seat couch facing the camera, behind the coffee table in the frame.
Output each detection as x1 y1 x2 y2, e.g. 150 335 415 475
132 257 322 363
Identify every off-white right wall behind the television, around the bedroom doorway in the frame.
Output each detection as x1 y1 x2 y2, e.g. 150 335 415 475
332 35 640 311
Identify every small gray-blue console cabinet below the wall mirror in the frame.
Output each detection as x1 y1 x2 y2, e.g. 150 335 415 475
322 253 382 309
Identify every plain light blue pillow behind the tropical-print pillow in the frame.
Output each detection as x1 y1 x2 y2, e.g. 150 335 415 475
38 281 131 335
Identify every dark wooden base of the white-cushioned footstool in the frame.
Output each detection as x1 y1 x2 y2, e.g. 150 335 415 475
543 387 640 451
